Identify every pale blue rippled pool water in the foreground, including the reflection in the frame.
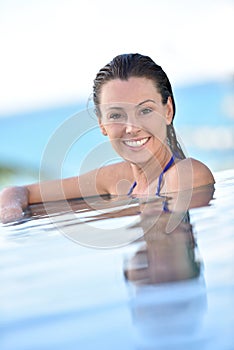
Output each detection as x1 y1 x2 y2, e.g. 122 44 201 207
0 170 234 350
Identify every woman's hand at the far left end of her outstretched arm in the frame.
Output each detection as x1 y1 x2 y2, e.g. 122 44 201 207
0 187 28 224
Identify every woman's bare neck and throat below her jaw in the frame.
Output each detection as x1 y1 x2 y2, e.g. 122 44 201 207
131 146 172 194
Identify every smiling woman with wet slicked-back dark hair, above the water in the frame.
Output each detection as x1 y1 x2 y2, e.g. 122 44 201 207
0 54 214 222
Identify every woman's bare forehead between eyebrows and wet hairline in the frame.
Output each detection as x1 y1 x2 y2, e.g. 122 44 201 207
100 77 161 104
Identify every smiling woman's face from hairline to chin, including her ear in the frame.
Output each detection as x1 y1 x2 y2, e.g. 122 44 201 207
99 77 173 164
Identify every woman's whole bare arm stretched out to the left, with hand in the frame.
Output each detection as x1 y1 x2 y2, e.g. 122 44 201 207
0 162 132 223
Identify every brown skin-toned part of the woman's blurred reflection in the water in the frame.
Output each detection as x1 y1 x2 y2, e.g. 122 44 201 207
125 213 200 284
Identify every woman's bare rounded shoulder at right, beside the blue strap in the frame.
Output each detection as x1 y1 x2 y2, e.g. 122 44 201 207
166 158 215 192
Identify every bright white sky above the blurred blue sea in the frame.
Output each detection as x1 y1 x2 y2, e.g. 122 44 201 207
0 0 234 116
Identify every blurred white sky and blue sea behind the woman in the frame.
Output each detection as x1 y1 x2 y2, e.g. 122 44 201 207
0 0 234 187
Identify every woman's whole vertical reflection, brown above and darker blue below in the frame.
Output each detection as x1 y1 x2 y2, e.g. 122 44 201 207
124 206 210 350
